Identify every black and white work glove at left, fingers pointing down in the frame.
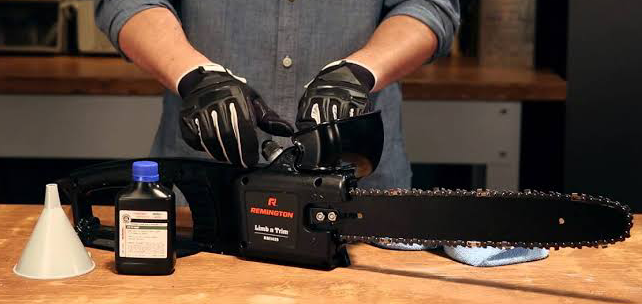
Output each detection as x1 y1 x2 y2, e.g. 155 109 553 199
178 64 294 167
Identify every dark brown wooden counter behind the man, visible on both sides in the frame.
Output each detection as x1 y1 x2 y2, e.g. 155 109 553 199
0 56 566 101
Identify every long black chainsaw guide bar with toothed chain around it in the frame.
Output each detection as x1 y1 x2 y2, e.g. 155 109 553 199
339 188 633 249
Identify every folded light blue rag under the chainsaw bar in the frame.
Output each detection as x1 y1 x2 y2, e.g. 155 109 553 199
372 243 548 267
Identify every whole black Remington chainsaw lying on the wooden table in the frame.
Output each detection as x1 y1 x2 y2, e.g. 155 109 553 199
58 112 633 269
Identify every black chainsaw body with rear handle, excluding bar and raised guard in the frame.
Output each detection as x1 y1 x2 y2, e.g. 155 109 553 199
58 147 356 269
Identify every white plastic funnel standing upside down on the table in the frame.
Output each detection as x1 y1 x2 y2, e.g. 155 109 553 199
13 184 96 279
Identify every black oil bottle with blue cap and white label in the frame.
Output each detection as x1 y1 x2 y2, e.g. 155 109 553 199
114 161 176 275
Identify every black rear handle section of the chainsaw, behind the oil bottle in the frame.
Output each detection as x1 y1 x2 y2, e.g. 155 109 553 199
57 158 251 252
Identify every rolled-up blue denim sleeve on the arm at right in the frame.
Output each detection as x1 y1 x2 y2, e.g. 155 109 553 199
384 0 460 61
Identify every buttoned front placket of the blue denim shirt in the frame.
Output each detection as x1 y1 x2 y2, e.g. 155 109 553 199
275 0 302 120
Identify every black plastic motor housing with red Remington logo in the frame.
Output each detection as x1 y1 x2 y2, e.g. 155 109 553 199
235 171 352 269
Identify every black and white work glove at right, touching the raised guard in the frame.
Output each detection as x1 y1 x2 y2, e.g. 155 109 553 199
296 60 376 131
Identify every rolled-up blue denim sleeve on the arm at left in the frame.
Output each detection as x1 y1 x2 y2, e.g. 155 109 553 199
95 0 178 54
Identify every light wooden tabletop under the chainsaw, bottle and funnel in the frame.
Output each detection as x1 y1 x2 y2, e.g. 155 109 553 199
0 205 642 303
